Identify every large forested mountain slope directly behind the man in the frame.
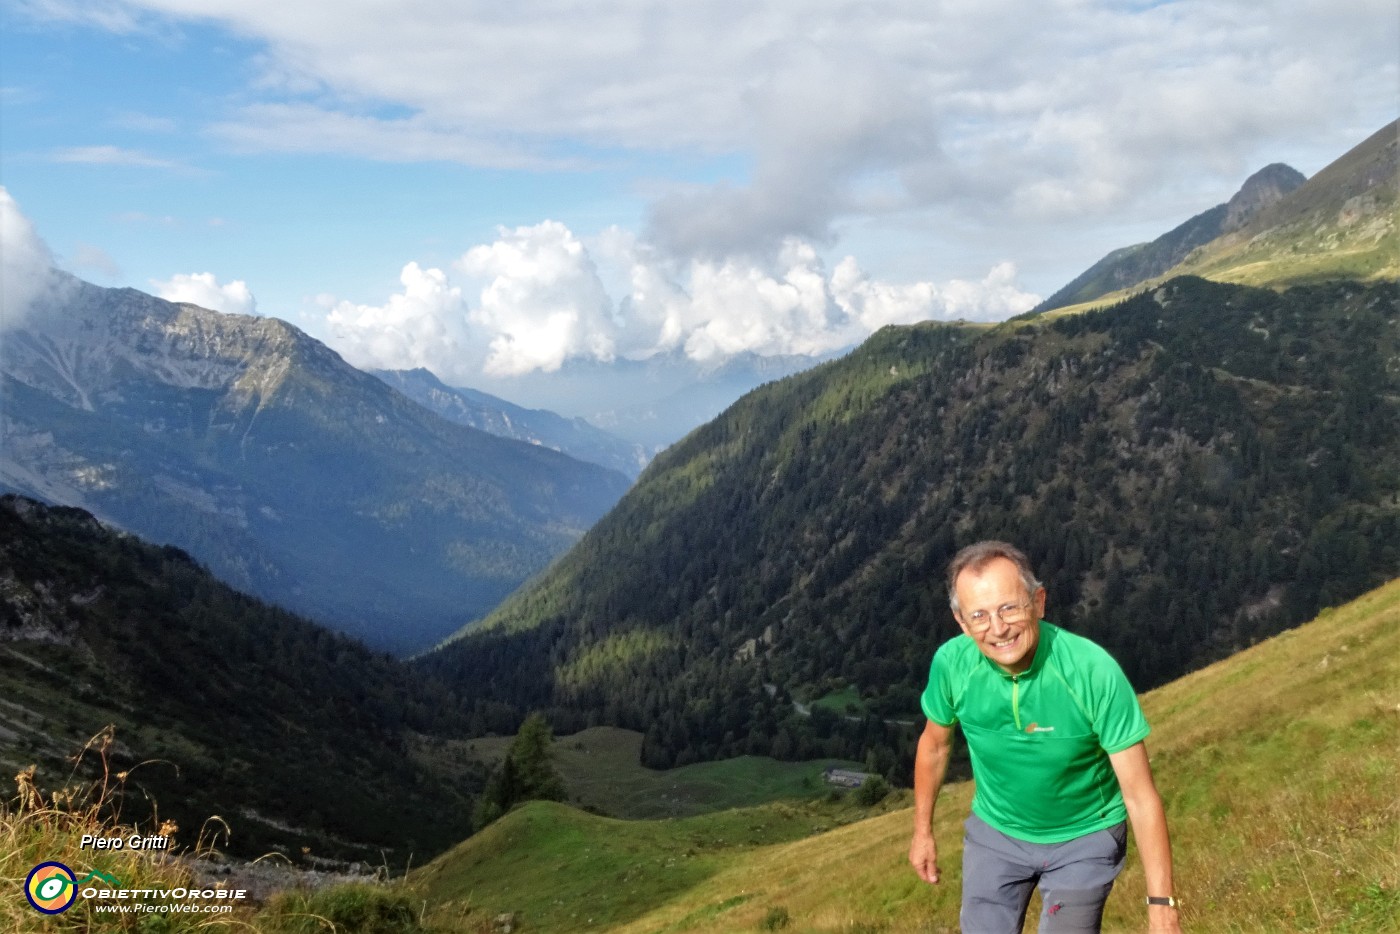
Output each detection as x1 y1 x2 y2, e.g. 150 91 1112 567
419 277 1400 774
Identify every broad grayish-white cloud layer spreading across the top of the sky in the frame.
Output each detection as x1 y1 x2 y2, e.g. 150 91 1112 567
20 0 1400 262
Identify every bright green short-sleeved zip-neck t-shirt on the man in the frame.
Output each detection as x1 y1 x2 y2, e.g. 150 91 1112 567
921 622 1149 843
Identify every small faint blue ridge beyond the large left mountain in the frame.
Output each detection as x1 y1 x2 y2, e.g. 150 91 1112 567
370 367 652 479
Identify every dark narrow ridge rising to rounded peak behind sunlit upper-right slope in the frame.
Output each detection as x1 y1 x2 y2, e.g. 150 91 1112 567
1033 162 1306 312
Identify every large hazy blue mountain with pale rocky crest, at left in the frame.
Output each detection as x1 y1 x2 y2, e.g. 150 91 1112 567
0 277 627 651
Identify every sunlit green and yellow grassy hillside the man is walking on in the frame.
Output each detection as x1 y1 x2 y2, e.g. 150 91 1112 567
414 580 1400 934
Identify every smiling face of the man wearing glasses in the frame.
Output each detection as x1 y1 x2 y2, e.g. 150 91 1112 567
955 557 1046 675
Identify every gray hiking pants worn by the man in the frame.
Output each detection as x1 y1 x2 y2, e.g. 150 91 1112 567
960 815 1127 934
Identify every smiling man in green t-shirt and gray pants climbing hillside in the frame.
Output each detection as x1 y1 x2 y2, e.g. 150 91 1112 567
909 542 1180 934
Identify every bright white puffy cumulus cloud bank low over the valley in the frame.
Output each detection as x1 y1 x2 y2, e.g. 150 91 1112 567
321 221 1039 385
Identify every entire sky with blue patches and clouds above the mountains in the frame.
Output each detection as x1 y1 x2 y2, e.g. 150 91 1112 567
0 0 1400 406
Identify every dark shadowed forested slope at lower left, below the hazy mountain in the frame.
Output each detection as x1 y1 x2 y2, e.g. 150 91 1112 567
0 496 479 865
